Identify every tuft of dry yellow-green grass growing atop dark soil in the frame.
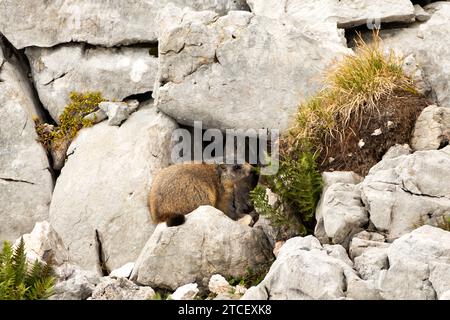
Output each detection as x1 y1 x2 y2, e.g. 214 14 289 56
281 32 416 160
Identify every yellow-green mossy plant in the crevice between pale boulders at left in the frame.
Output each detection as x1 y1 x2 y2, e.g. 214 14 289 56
35 92 104 149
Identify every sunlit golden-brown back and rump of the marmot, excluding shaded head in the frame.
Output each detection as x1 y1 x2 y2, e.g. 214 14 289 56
149 163 221 226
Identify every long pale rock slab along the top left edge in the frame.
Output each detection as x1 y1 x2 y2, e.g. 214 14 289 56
0 0 248 49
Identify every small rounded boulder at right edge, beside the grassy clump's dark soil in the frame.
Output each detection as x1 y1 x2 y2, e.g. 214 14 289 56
411 105 450 150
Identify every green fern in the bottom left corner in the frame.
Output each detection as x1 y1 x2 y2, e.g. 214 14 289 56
0 239 55 300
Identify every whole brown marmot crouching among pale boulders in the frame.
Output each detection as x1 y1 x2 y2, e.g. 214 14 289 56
148 163 257 226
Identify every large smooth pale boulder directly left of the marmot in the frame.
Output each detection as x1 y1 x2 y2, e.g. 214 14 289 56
50 104 176 271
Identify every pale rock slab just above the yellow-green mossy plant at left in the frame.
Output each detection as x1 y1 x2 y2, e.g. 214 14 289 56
25 44 158 122
